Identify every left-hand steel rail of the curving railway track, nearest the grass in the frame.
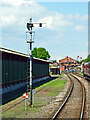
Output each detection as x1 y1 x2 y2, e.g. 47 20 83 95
52 75 74 120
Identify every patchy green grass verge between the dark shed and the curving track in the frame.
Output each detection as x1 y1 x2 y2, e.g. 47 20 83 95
2 78 66 118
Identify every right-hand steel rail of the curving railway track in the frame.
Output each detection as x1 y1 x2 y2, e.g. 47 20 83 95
70 74 86 120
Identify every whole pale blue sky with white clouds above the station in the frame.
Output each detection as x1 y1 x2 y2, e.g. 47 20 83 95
0 0 88 60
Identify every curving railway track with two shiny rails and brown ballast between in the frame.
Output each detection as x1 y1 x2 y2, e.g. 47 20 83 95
52 74 85 120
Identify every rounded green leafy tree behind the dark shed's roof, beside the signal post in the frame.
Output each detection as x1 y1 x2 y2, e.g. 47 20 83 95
32 47 50 60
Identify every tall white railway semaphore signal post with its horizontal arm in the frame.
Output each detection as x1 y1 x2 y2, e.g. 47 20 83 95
27 18 46 106
